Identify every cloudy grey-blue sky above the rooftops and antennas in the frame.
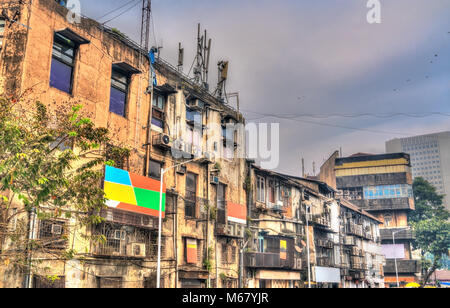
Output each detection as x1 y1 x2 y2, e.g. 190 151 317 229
81 0 450 175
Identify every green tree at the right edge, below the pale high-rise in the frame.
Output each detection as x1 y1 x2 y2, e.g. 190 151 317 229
409 178 450 287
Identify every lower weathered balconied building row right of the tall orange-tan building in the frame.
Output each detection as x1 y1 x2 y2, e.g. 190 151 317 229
244 162 384 288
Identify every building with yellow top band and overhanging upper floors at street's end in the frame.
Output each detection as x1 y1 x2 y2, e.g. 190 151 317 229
320 152 420 286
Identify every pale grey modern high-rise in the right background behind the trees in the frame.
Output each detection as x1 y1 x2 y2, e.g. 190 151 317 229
386 132 450 209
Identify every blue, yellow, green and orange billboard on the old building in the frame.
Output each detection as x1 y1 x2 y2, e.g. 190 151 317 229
104 166 166 218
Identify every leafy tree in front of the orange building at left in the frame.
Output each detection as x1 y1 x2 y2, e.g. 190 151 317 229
0 98 129 286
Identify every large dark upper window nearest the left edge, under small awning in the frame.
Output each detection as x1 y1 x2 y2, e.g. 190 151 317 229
50 33 76 94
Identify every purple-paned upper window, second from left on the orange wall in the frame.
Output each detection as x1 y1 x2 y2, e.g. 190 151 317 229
109 67 129 117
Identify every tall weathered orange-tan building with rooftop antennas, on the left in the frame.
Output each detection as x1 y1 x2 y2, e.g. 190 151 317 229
0 0 246 288
